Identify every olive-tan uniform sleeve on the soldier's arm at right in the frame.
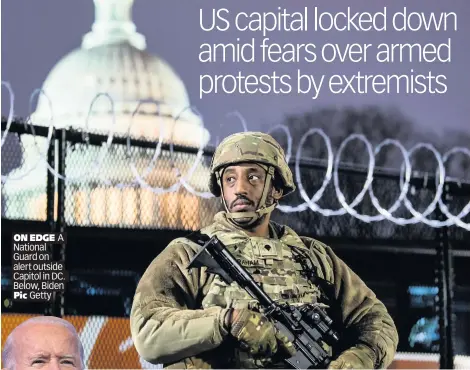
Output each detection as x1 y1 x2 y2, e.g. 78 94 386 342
308 238 398 368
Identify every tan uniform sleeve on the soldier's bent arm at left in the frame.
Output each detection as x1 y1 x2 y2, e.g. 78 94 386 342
130 242 226 364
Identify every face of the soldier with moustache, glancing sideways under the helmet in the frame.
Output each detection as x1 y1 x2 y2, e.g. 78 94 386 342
222 163 266 212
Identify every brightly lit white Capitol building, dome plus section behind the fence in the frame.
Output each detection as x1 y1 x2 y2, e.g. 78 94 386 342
3 0 215 230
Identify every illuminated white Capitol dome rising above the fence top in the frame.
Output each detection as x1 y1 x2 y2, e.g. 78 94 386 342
32 0 209 147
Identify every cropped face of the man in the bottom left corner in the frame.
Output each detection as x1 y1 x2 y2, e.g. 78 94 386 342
13 324 81 369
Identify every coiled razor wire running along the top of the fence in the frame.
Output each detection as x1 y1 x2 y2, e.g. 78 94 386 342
1 81 470 230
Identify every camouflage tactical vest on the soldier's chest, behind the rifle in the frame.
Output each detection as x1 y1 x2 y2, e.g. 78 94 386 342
196 221 332 368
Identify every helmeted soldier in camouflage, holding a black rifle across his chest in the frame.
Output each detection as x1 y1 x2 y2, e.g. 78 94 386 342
130 132 398 369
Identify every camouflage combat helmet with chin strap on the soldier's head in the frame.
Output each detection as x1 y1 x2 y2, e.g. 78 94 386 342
209 132 295 226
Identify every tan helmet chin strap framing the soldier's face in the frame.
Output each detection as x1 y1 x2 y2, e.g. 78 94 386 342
216 166 277 227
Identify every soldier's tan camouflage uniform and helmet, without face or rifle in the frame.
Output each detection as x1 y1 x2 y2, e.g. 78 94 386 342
130 133 398 368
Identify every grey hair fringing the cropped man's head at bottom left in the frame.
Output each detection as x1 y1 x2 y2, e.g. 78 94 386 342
2 316 85 370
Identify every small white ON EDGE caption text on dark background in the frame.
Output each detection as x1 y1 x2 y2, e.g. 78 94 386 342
11 233 68 302
